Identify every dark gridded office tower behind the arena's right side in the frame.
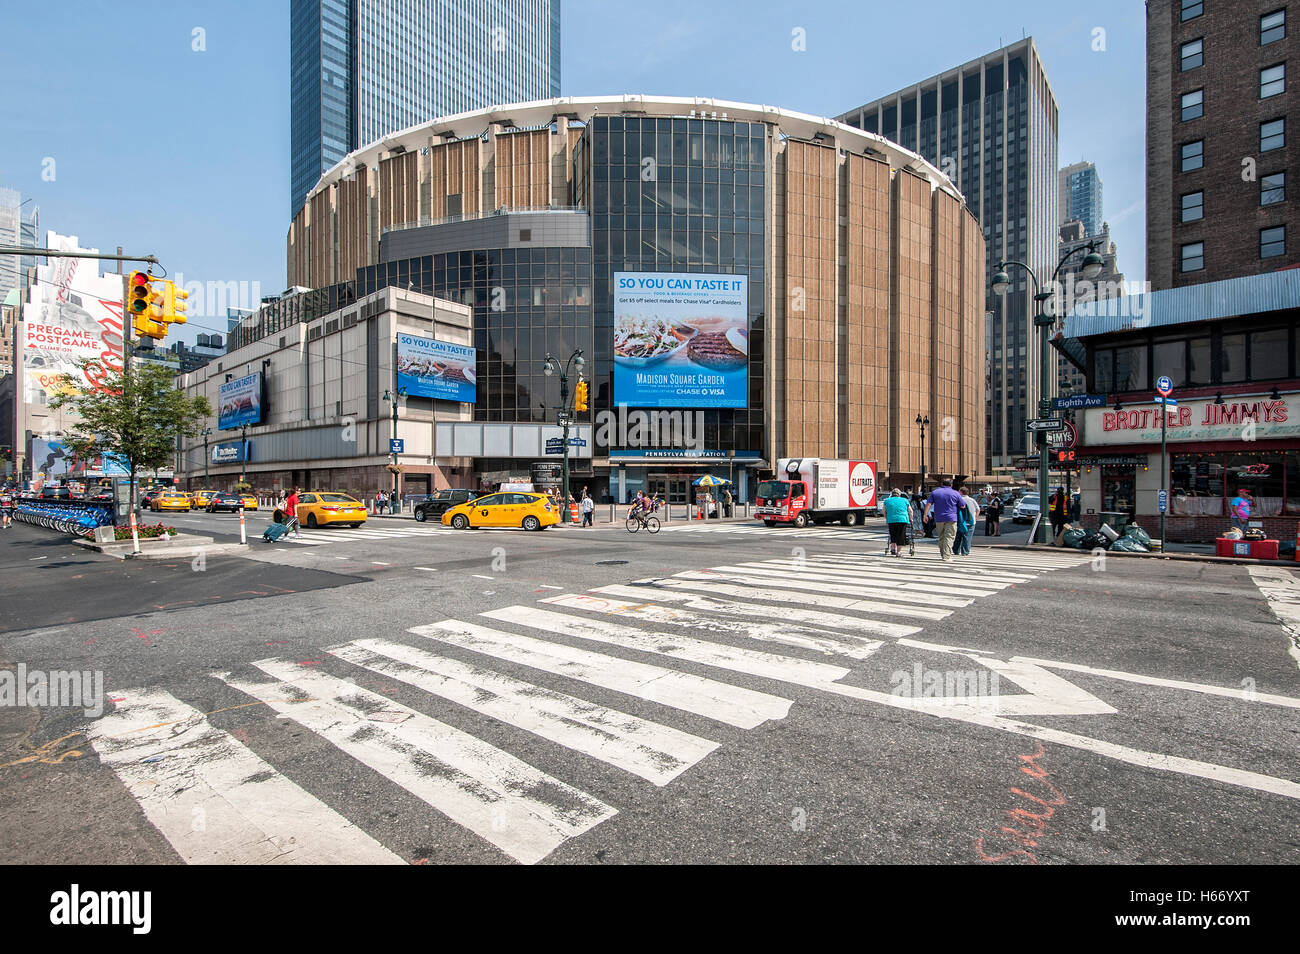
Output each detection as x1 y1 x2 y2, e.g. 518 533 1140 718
836 38 1061 468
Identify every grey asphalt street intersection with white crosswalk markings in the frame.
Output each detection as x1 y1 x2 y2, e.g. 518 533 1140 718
0 515 1300 864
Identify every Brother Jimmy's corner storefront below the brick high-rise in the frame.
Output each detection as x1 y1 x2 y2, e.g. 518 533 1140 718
1062 270 1300 542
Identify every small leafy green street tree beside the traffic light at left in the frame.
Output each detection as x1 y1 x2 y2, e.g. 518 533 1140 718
49 359 212 507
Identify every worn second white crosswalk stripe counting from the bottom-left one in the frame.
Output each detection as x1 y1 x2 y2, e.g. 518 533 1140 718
217 659 616 864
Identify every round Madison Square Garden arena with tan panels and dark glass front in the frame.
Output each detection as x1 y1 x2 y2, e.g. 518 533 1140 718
230 96 985 500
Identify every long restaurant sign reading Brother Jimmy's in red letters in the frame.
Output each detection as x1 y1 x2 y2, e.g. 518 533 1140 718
1083 394 1300 447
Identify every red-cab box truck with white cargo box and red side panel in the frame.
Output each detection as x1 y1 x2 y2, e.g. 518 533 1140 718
754 458 879 526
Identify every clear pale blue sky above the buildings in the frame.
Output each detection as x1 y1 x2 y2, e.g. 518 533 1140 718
0 0 1145 341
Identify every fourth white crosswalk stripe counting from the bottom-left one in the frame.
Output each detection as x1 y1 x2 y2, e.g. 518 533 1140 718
408 620 792 729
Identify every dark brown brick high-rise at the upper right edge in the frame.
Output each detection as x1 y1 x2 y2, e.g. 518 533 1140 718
1147 0 1300 290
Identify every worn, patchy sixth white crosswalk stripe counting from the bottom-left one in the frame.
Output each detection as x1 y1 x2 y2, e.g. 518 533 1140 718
541 593 899 659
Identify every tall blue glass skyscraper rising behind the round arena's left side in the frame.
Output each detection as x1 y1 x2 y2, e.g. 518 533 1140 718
290 0 560 209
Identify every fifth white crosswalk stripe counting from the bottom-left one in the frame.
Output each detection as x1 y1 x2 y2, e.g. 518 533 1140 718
482 606 849 685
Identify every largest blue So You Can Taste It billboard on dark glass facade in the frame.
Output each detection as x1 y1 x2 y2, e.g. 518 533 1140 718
614 272 749 408
